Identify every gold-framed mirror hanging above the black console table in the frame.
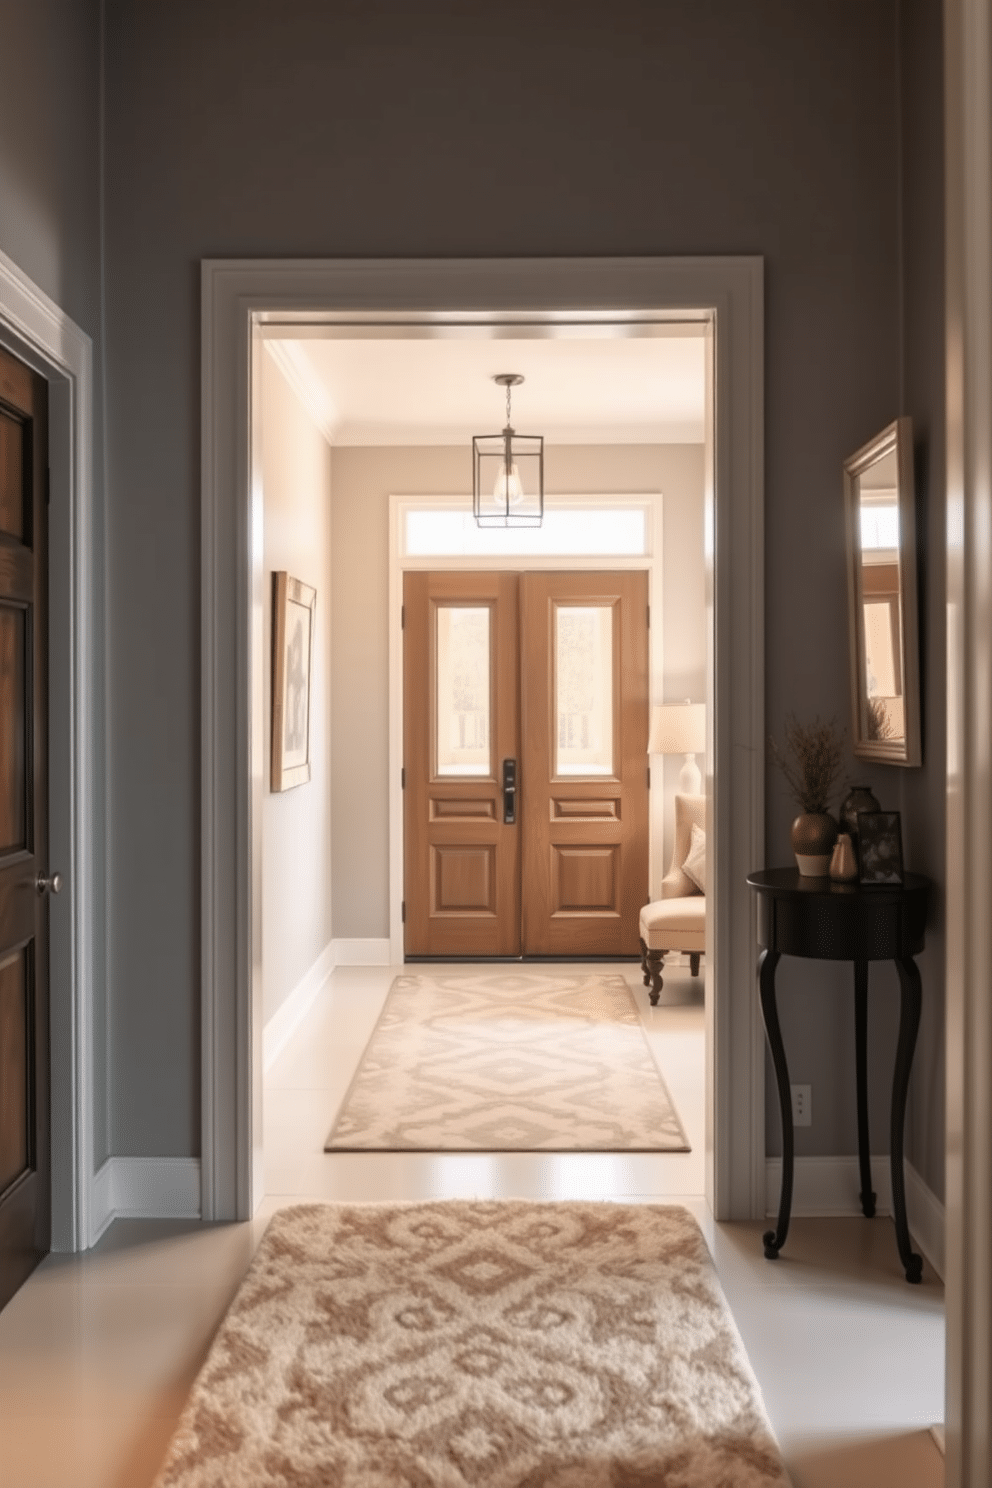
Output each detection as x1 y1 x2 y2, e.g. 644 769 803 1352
843 418 922 765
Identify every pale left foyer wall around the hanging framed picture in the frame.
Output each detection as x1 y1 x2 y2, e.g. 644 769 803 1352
259 353 332 1022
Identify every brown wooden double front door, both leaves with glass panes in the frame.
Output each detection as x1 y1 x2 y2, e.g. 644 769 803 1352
403 571 648 957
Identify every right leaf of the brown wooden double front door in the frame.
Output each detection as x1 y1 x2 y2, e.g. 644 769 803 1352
521 573 648 955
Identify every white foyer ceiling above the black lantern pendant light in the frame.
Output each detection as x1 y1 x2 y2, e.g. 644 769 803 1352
269 336 705 445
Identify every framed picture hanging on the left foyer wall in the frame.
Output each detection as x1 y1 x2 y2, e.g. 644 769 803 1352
271 568 317 792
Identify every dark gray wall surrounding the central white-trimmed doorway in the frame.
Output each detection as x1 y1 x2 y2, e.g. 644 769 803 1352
98 0 940 1183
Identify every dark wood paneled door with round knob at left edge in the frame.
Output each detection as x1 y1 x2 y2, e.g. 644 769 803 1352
0 342 51 1306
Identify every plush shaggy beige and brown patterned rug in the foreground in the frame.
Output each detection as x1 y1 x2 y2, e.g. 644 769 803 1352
158 1202 788 1488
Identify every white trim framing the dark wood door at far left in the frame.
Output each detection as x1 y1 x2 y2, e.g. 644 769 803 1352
0 253 99 1251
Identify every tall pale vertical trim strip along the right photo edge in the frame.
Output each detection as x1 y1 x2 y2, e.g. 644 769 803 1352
944 0 992 1488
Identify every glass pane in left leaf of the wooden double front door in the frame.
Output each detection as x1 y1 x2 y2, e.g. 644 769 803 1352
436 604 492 778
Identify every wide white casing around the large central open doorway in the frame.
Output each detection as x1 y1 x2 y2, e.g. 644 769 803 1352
201 257 764 1219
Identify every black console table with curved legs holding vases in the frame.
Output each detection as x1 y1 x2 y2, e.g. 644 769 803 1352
748 868 930 1281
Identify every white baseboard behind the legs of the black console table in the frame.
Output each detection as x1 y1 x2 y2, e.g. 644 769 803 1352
764 1153 944 1280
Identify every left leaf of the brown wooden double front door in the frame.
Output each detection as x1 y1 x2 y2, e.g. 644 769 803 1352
403 573 521 955
